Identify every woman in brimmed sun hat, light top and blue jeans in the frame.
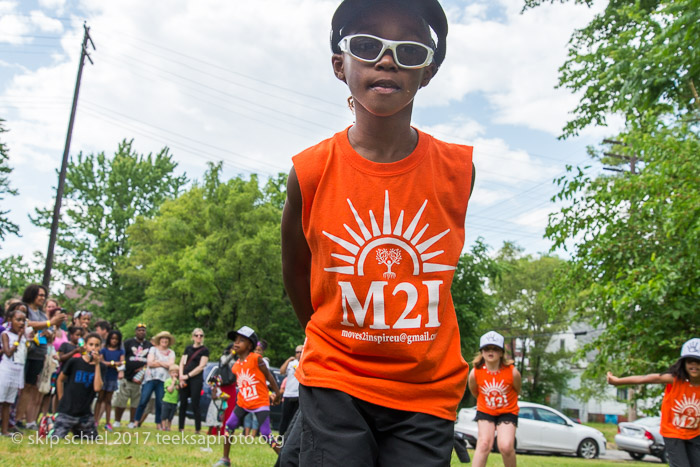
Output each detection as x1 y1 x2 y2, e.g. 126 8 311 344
136 331 175 430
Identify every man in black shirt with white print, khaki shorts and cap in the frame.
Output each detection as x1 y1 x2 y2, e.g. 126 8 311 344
112 323 152 428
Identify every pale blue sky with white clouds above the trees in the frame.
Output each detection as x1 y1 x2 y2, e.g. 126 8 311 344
0 0 614 278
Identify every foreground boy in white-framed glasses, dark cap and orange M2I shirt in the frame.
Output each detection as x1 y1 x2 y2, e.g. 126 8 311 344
280 0 474 466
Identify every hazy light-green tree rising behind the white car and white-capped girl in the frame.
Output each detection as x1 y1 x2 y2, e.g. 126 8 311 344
482 242 571 402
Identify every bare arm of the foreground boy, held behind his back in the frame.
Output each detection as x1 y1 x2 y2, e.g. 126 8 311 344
281 168 314 329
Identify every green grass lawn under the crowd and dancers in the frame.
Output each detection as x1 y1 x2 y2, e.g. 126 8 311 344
0 427 649 467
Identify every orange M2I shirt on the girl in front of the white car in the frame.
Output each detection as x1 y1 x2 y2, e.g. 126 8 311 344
474 365 519 416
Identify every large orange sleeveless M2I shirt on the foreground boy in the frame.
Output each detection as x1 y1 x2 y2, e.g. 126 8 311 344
294 126 472 420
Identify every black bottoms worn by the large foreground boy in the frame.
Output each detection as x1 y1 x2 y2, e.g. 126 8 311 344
299 385 454 467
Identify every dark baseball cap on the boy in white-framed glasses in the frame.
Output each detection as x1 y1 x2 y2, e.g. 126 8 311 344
331 0 447 67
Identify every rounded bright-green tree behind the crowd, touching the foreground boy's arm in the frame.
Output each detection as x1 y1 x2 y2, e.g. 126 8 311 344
120 164 303 361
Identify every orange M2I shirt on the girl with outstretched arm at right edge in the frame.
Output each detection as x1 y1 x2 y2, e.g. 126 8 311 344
660 379 700 439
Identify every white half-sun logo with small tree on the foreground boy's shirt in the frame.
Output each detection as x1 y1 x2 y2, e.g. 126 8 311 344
323 190 455 279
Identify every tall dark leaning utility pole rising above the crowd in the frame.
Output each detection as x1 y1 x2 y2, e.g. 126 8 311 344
42 23 96 289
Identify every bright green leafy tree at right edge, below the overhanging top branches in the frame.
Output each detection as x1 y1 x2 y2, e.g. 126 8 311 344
547 126 700 376
